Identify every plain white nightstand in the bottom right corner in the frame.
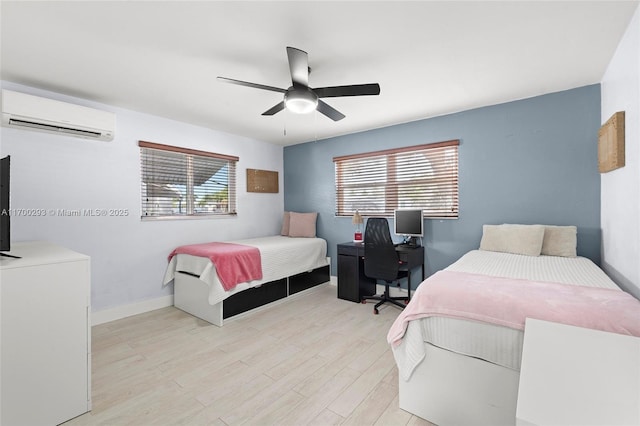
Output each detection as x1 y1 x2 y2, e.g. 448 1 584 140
516 319 640 426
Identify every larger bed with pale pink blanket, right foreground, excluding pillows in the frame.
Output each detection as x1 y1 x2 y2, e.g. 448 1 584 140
387 225 640 426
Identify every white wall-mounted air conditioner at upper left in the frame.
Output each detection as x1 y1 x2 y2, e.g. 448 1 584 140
2 89 116 141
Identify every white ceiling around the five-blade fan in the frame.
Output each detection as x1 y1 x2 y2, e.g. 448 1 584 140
0 0 638 145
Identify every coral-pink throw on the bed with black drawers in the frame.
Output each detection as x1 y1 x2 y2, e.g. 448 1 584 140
169 243 262 291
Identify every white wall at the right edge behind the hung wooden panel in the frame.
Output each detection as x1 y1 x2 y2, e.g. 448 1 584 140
601 8 640 298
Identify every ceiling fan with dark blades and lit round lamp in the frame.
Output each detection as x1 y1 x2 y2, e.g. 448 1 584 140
218 47 380 121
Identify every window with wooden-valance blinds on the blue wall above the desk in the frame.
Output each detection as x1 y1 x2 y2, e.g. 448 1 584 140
333 140 460 218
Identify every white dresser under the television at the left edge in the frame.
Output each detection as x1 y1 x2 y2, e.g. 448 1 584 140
0 242 91 426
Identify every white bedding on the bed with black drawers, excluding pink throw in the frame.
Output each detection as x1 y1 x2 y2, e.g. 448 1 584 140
164 235 329 305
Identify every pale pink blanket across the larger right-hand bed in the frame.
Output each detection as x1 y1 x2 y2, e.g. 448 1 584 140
387 271 640 345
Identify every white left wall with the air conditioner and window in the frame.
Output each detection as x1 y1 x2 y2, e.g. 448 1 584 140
0 82 284 311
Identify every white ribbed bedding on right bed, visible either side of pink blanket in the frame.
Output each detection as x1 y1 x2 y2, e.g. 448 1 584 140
394 250 618 378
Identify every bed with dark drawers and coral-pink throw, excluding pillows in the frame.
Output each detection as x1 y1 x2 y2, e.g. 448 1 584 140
164 235 329 326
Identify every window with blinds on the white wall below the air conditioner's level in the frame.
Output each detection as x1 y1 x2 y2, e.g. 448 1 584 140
138 141 238 219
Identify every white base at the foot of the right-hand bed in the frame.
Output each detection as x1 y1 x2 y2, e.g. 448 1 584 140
399 343 520 426
